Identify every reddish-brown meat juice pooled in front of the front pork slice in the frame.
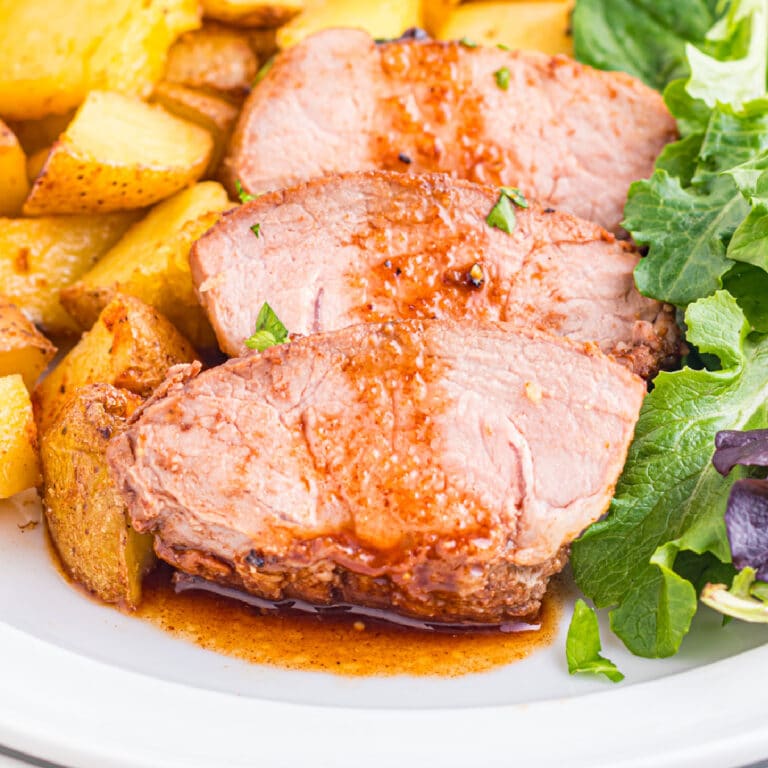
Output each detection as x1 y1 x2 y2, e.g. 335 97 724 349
135 566 564 677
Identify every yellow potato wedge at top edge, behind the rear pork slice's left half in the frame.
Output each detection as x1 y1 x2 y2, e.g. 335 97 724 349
277 0 421 49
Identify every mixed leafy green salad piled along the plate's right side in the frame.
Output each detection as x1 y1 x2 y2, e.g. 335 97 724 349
567 0 768 680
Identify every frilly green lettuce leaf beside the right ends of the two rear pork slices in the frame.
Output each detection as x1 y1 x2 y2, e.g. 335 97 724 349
624 99 768 306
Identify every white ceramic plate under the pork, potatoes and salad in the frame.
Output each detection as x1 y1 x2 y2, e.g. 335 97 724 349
0 497 768 768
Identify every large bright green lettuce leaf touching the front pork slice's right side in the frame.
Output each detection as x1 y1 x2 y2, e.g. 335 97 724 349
571 291 768 657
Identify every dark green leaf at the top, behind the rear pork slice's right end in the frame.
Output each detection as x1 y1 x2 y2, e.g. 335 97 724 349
573 0 722 90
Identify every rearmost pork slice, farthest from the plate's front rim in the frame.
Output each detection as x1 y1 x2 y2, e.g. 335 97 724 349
225 29 676 231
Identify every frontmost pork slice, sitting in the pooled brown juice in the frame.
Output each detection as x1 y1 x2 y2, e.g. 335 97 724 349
108 320 645 622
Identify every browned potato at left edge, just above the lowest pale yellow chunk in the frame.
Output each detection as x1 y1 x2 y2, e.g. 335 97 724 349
0 296 56 390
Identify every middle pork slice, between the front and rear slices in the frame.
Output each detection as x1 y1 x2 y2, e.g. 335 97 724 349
190 171 680 377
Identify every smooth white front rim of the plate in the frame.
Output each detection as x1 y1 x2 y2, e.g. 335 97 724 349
0 621 768 768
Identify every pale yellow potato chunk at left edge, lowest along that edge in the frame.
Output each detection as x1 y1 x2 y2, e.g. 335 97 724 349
0 374 40 499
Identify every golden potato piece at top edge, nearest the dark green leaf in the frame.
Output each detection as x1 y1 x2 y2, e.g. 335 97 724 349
435 0 573 54
